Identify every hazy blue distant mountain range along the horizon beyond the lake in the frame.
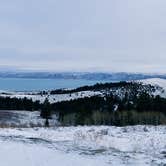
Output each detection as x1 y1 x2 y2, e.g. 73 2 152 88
0 71 166 81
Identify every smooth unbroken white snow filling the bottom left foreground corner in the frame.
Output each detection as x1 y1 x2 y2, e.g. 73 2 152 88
0 141 108 166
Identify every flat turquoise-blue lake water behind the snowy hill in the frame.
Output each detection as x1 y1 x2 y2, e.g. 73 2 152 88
0 78 109 91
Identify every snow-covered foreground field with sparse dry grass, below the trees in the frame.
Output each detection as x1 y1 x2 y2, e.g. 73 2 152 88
0 126 166 166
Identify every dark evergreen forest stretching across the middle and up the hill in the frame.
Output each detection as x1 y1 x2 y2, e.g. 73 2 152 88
0 82 166 126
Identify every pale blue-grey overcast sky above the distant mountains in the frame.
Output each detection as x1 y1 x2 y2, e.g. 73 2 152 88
0 0 166 73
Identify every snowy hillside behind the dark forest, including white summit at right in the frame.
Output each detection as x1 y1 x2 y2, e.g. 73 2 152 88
0 78 166 103
